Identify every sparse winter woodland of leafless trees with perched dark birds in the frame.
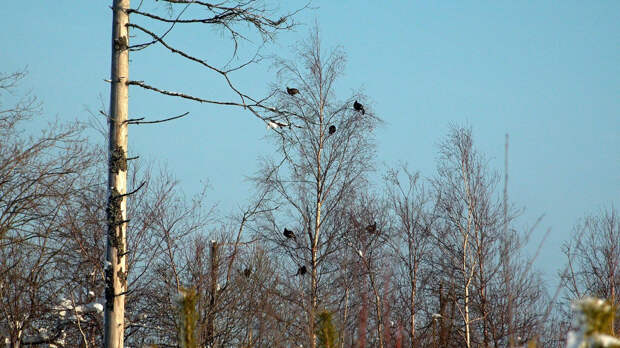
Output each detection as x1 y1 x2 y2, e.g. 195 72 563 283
0 0 620 348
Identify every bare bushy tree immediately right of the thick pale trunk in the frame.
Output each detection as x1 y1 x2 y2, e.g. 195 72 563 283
120 170 212 346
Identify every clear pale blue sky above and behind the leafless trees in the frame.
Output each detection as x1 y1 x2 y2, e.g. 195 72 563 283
0 0 620 286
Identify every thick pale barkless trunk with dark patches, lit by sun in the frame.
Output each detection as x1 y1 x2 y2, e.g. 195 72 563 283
104 0 129 348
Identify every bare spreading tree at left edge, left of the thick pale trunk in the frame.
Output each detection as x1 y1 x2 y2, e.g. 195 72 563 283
0 73 94 347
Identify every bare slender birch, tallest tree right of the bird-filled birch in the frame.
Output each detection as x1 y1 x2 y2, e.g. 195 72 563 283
433 128 544 347
